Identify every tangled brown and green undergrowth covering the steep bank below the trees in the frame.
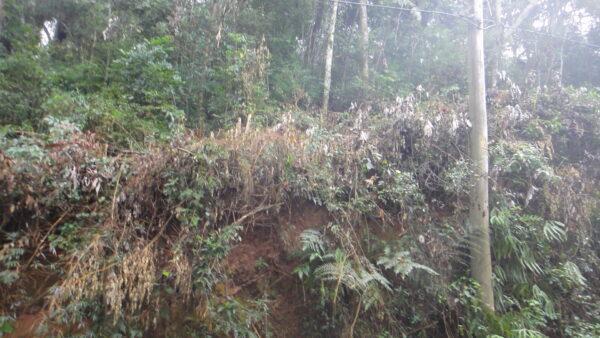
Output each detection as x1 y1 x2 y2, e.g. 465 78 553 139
0 86 600 337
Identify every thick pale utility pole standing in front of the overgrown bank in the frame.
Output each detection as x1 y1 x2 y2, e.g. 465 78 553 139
468 0 494 311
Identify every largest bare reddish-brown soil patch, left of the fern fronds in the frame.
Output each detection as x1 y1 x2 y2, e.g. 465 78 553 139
227 203 331 337
